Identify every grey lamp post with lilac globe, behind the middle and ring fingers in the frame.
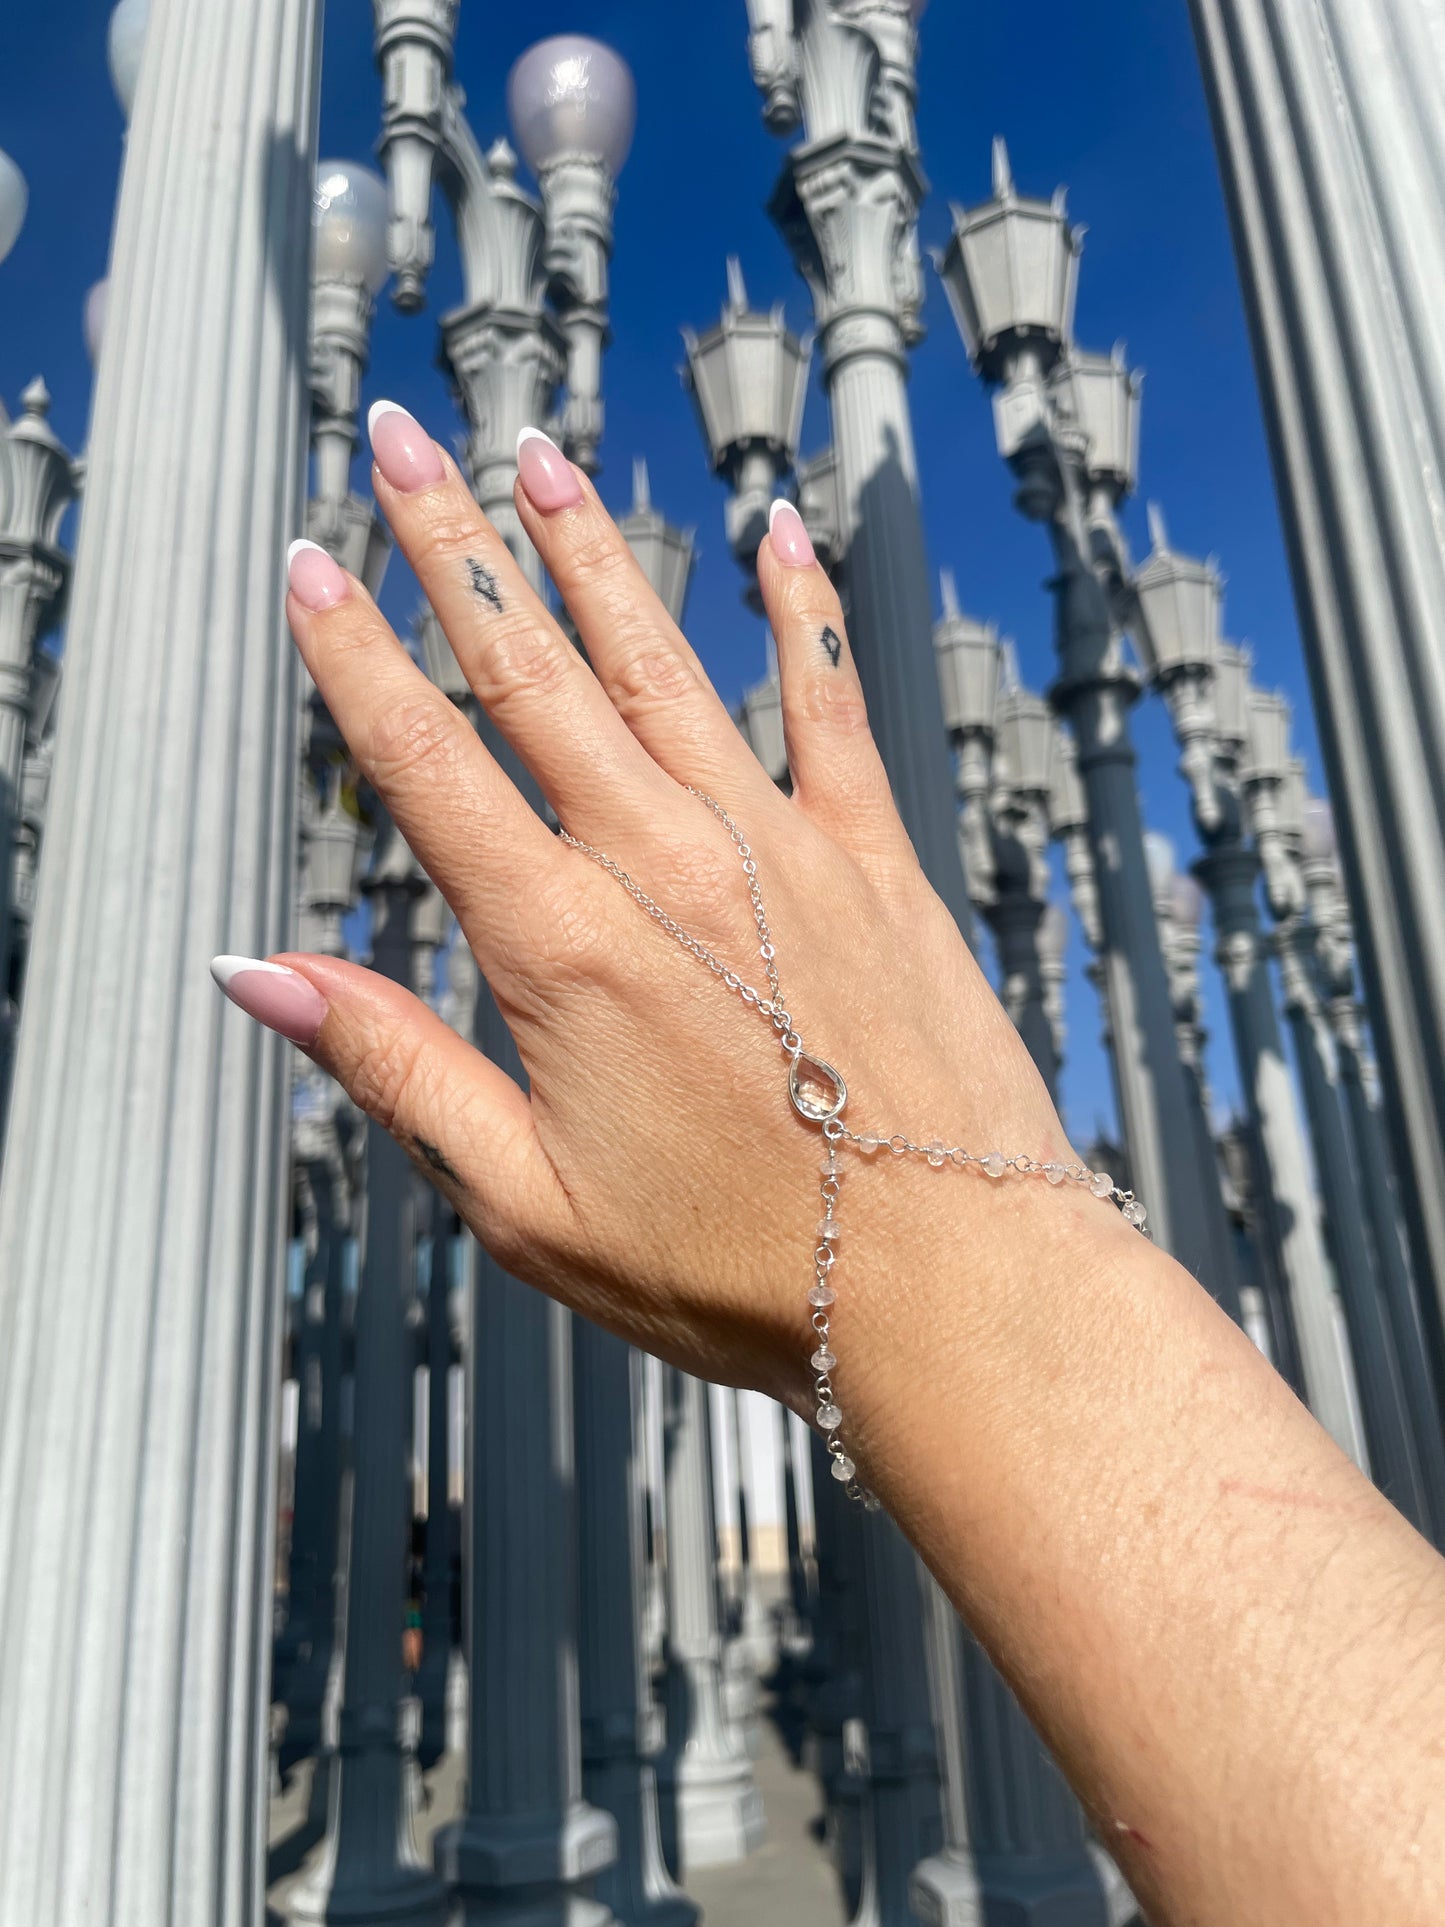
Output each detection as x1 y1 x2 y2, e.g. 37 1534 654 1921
378 26 634 1927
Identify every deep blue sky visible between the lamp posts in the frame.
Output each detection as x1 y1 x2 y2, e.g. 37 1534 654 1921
0 0 1320 1135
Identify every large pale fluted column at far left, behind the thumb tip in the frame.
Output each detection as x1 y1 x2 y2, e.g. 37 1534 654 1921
0 0 316 1927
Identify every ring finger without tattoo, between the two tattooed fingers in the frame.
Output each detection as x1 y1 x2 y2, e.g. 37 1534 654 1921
516 428 782 796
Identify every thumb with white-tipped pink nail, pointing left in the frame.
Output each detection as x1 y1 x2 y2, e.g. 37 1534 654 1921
210 954 570 1264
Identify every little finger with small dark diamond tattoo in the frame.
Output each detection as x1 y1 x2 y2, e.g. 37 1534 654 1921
757 501 907 874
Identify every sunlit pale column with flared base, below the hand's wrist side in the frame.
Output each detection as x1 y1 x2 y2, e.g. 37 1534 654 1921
663 1372 763 1873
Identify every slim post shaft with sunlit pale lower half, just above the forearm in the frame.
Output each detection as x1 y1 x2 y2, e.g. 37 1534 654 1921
1195 844 1366 1459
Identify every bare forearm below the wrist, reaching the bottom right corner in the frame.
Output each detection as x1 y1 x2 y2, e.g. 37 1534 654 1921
834 1177 1445 1927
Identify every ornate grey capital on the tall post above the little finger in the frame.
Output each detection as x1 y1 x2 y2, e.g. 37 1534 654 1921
771 135 929 380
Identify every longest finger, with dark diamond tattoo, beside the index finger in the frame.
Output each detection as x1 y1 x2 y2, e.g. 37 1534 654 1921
368 401 676 834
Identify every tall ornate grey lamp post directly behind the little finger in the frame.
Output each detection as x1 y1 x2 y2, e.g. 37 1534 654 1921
751 0 971 937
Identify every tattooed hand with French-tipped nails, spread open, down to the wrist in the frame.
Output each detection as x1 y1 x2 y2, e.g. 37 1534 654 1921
217 409 1114 1433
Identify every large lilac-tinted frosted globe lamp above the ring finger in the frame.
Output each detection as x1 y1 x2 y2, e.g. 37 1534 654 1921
507 33 638 175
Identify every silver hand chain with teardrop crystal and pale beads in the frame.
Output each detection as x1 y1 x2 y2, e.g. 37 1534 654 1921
559 784 1146 1507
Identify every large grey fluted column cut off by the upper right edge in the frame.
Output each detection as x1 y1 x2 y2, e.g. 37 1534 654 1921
1191 0 1445 1368
